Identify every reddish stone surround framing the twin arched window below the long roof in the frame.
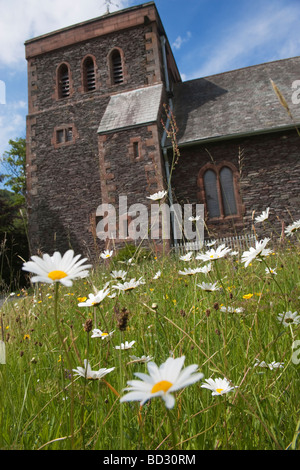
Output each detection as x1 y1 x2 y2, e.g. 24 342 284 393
197 160 245 222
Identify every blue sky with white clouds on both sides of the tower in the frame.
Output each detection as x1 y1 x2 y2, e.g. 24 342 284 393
0 0 300 163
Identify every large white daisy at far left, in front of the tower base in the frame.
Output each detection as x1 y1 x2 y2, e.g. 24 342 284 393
22 250 92 287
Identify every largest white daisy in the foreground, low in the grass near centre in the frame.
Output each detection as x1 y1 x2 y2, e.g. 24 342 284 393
120 356 204 408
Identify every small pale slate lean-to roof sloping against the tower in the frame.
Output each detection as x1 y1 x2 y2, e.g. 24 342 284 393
98 84 163 134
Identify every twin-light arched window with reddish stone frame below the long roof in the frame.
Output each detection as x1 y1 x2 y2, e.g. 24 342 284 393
198 162 242 219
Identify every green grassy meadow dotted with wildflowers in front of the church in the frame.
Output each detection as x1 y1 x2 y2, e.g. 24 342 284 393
0 234 300 451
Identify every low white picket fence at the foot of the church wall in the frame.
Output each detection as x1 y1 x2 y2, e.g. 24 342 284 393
172 233 256 254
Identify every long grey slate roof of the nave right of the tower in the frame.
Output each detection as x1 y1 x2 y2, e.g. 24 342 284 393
173 57 300 145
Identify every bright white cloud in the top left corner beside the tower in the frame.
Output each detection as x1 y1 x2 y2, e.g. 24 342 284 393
0 0 129 67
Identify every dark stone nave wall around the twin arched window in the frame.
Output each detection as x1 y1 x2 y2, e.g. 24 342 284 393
172 130 300 237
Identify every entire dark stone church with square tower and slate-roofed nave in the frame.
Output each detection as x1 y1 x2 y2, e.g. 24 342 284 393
25 1 300 257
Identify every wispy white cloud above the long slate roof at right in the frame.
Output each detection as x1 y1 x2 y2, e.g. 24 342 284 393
185 2 300 79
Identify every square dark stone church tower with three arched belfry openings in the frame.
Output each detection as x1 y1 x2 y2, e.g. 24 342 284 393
25 2 181 255
